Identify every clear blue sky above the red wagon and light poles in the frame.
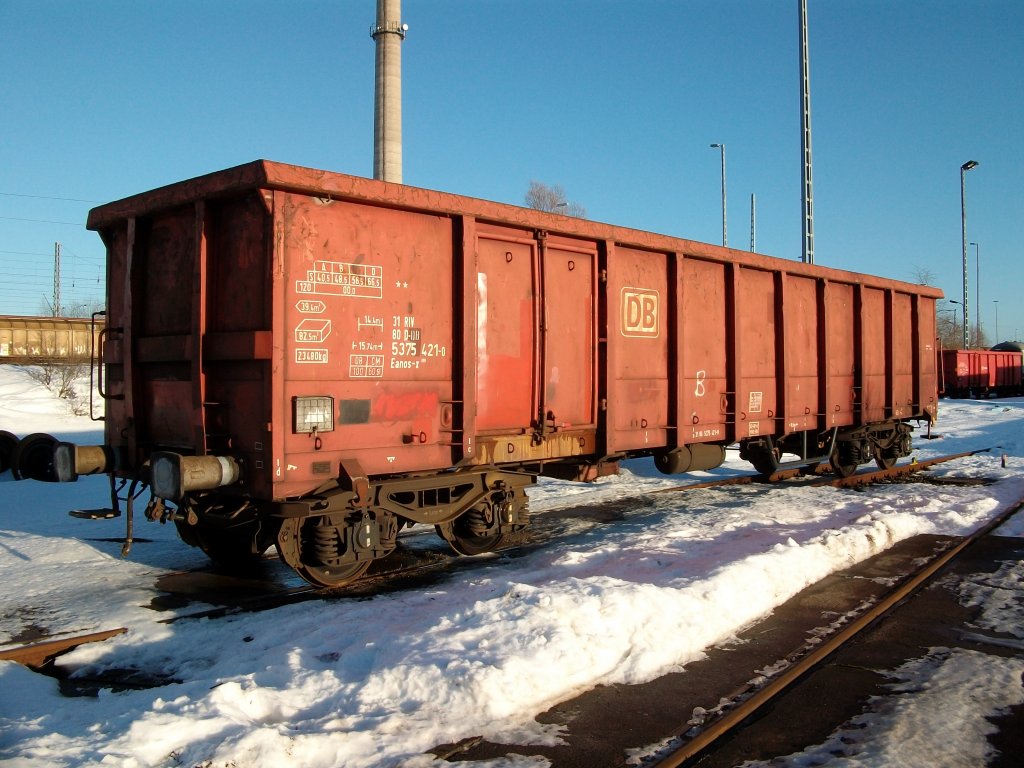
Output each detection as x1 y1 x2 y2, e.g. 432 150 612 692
0 0 1024 339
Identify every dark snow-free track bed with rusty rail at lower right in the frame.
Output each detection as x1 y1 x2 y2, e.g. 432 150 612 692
430 483 1024 768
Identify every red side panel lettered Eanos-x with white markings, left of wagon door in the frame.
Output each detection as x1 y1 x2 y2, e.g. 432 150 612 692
274 194 454 495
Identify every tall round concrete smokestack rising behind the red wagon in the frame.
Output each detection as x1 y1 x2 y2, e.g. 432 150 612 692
370 0 409 183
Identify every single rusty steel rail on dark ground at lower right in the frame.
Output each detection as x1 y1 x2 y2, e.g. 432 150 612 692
648 489 1024 768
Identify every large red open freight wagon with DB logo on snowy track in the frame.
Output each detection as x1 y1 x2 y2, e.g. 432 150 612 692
46 161 941 585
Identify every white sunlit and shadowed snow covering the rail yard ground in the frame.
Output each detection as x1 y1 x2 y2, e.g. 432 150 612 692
0 367 1024 768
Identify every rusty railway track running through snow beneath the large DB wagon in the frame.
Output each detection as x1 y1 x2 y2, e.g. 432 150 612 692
0 449 1003 684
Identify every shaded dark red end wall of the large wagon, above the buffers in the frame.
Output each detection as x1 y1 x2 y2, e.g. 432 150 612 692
96 194 278 484
